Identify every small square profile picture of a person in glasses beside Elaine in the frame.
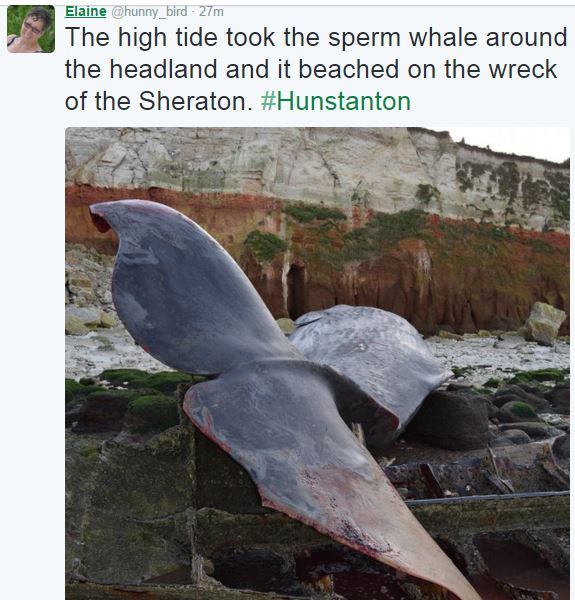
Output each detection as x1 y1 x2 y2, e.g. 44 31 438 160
6 5 55 54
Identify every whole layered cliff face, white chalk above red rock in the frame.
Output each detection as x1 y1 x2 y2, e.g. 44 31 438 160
66 128 569 332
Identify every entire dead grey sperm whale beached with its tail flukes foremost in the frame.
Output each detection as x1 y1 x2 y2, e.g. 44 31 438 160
90 199 480 600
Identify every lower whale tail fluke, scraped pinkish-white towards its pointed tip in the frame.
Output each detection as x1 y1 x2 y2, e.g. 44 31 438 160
184 360 479 600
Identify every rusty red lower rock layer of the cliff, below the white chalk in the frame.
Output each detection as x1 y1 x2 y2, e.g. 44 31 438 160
66 186 569 333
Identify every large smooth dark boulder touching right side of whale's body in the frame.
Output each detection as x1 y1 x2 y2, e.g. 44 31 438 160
406 389 489 450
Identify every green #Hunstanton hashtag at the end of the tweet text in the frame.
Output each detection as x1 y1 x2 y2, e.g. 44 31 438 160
261 90 411 111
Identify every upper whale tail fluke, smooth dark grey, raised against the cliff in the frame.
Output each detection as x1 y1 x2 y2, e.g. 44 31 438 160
90 200 300 375
